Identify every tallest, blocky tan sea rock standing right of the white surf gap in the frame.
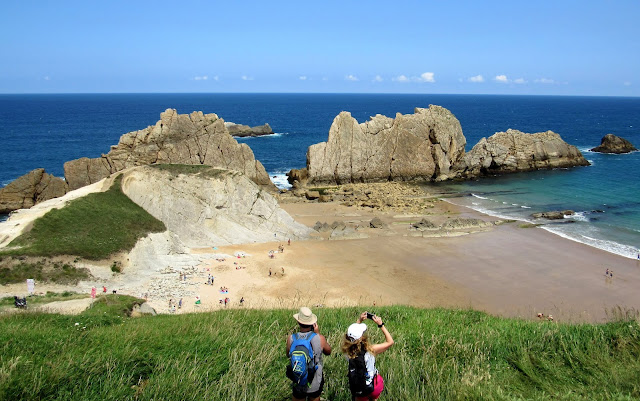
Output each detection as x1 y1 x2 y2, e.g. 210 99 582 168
307 105 466 184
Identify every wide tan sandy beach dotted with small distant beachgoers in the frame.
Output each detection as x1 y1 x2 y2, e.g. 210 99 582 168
1 184 640 322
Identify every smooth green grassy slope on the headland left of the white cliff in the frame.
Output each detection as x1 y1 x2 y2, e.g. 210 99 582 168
2 177 166 260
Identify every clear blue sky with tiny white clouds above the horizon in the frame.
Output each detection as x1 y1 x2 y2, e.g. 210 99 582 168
0 0 640 96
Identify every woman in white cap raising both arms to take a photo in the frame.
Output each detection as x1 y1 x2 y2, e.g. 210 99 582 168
342 312 393 401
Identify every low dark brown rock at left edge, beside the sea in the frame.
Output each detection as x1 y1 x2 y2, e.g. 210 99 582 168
0 168 67 213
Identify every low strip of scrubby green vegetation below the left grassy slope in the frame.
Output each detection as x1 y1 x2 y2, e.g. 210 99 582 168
0 260 91 285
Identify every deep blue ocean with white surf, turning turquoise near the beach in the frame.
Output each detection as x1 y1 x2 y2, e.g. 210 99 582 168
0 94 640 258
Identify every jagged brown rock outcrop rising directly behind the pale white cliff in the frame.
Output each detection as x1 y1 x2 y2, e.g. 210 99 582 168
64 109 275 190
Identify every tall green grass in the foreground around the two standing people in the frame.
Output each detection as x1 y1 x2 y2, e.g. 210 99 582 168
0 304 640 400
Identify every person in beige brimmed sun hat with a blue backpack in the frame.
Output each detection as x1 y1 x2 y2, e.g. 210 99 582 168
286 306 331 401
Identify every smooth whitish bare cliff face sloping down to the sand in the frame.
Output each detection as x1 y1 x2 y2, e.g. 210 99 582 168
122 166 311 247
